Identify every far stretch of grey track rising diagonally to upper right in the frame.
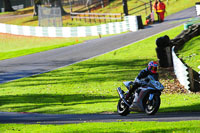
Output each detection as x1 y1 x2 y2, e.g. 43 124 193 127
0 7 196 83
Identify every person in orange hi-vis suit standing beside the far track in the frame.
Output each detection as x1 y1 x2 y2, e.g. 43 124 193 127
157 0 166 22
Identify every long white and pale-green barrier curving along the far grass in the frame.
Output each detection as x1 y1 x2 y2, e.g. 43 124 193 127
0 16 138 37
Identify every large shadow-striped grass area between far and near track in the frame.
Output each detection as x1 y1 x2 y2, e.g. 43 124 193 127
0 26 197 114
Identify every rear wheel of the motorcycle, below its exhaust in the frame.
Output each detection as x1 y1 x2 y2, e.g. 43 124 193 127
117 99 130 116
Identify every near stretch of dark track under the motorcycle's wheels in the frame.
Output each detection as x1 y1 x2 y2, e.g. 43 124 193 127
0 112 200 124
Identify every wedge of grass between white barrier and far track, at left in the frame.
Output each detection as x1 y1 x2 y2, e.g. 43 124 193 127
0 34 101 60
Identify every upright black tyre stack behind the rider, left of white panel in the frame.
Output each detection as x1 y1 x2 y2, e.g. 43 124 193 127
156 35 173 67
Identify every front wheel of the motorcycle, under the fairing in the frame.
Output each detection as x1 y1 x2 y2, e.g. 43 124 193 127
144 95 160 115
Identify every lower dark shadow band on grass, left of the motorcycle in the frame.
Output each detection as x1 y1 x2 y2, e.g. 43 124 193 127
0 94 116 113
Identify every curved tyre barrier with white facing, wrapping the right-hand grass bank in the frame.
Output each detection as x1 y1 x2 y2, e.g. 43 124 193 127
170 24 200 92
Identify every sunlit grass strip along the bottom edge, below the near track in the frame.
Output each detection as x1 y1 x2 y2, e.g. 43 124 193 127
0 121 200 133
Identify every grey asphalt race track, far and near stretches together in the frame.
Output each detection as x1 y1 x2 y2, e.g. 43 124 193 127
0 7 200 124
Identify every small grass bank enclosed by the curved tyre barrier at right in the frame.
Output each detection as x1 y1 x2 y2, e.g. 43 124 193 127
178 36 200 72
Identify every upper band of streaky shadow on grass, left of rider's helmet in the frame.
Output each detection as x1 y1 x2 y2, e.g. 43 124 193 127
1 59 150 87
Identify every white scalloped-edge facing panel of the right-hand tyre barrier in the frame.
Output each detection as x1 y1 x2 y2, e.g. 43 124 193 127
172 46 190 90
